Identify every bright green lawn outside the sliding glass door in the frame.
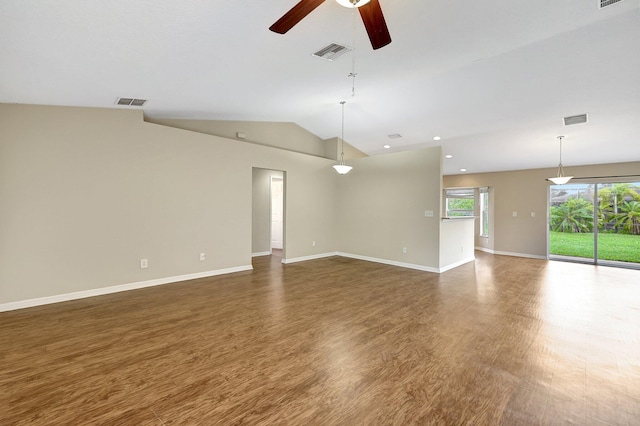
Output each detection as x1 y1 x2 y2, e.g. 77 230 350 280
549 231 640 263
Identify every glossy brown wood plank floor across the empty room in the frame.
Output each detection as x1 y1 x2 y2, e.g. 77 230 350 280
0 253 640 426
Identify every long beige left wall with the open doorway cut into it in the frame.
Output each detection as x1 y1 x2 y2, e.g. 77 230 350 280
0 104 338 303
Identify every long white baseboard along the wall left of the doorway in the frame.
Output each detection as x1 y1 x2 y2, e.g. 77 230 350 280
0 265 253 312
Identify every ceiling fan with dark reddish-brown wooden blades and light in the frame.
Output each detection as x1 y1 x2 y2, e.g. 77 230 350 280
269 0 391 50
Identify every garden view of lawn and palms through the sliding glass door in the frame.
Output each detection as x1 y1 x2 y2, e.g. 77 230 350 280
548 182 640 268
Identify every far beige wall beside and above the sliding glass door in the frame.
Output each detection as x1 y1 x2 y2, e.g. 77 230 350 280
443 162 640 257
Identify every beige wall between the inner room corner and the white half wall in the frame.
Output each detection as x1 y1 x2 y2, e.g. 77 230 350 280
338 147 441 269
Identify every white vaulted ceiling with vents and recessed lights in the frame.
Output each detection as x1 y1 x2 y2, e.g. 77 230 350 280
0 0 640 174
